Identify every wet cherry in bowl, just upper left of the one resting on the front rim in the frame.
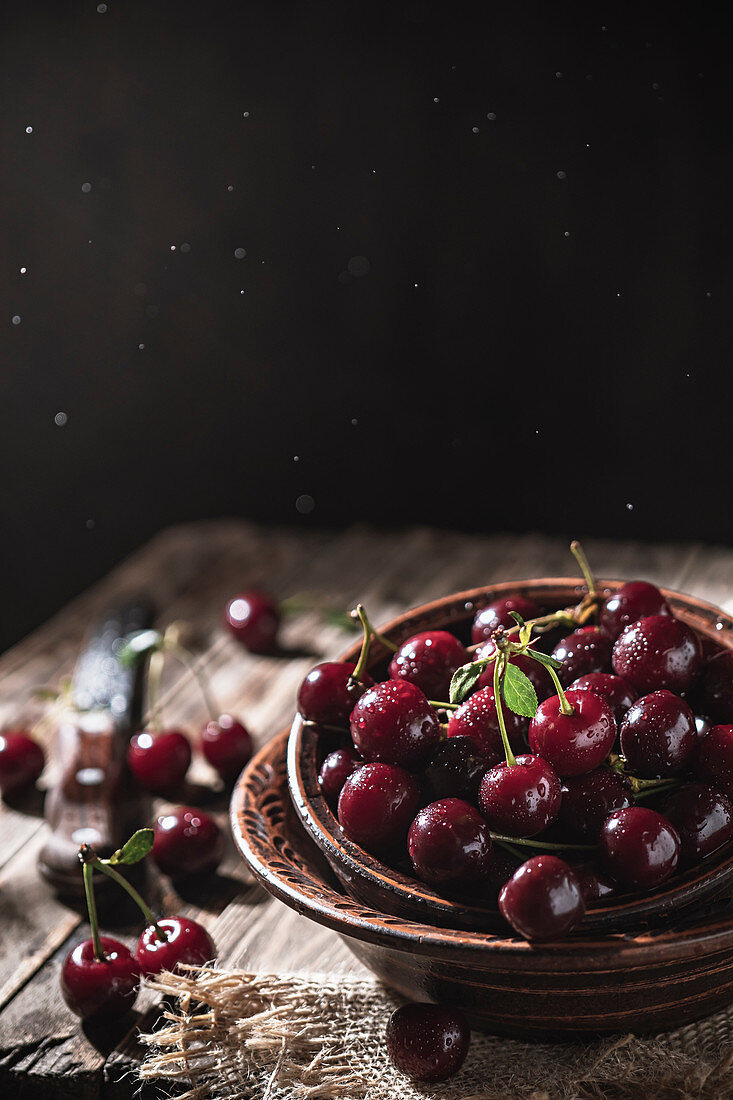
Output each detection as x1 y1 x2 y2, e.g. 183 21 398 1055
407 799 492 884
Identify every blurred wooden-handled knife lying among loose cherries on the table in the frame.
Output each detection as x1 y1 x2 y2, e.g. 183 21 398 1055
39 605 149 894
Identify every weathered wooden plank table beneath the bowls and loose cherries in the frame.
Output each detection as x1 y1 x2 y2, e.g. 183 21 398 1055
0 520 733 1100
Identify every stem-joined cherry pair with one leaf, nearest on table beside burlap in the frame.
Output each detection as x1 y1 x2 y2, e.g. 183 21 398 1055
61 829 216 1021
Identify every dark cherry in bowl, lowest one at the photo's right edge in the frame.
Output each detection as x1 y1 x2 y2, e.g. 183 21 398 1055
661 783 733 867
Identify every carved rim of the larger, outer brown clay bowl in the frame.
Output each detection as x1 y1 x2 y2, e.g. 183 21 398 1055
230 729 733 972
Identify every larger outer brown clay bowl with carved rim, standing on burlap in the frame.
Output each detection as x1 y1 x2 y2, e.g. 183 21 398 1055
231 730 733 1040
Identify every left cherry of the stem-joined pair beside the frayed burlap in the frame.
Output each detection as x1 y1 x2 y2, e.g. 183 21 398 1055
61 936 140 1020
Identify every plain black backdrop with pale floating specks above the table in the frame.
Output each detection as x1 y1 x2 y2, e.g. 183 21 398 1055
0 0 733 645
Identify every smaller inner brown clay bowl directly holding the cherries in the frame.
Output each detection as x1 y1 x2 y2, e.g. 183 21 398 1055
287 580 733 934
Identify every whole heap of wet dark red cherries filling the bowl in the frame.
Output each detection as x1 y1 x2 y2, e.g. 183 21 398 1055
298 570 733 939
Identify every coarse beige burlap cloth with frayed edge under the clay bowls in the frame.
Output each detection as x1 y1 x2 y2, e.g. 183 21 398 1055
141 968 733 1100
